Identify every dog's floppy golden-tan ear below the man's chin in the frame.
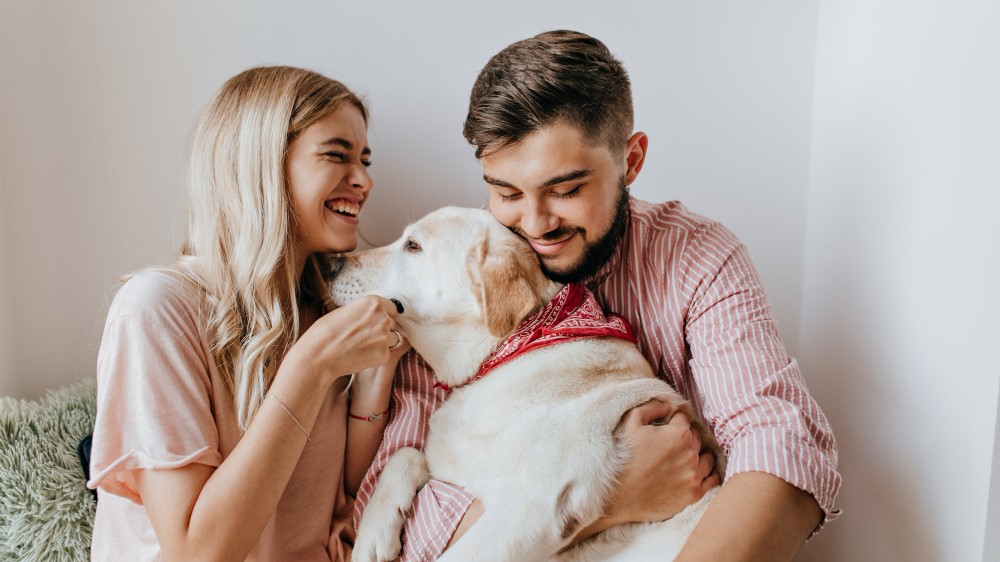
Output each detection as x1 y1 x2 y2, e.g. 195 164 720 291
474 233 547 338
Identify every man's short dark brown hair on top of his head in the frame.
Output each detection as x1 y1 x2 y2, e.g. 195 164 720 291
463 30 633 158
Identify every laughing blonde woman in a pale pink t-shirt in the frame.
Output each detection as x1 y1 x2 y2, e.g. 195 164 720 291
88 67 408 562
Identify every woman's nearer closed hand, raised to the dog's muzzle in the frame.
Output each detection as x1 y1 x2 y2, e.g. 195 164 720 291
286 295 408 383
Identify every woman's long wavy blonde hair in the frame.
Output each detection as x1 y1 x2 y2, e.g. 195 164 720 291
176 66 368 430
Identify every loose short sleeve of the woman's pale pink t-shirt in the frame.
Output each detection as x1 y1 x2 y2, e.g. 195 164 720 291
87 272 222 498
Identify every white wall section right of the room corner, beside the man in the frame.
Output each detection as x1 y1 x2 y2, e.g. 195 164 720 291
800 0 1000 561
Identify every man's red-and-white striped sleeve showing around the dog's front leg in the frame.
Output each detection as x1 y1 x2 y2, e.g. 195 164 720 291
354 351 475 561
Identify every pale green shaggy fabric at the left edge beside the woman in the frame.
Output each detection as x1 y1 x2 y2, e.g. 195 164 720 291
0 380 97 562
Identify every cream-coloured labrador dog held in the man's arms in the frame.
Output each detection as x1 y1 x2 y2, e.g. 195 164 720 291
331 207 724 562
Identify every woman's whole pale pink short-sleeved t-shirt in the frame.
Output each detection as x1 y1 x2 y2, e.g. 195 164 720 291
87 271 353 562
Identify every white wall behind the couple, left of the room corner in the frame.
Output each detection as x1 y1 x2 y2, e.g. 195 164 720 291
0 0 816 397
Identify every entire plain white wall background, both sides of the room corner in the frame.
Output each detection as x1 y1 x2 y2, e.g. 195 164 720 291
0 0 1000 561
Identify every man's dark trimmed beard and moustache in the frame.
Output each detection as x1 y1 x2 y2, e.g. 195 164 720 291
511 174 628 283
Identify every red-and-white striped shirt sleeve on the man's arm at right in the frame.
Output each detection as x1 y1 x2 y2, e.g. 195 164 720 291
687 227 841 523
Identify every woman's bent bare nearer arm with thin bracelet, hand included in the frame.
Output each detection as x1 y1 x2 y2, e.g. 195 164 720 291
136 297 395 561
